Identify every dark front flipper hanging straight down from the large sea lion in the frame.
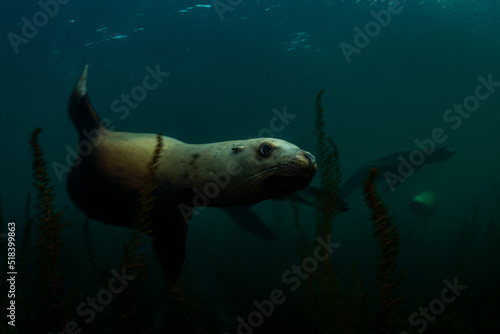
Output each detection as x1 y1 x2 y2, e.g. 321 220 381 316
151 207 188 283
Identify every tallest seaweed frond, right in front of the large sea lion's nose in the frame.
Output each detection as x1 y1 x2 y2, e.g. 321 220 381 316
295 90 353 333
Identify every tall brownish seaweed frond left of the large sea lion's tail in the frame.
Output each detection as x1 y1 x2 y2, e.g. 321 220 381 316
30 128 72 331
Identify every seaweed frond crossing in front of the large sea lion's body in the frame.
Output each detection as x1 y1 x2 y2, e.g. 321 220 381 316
113 135 163 333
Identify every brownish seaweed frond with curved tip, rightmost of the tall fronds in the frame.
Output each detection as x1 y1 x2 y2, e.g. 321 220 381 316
363 168 404 333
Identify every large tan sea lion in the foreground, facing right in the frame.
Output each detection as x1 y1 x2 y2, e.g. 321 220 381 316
67 66 317 281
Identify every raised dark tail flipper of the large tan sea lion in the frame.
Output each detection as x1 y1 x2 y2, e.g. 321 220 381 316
68 65 106 137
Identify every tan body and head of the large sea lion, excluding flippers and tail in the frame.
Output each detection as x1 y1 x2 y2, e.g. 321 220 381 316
68 130 315 226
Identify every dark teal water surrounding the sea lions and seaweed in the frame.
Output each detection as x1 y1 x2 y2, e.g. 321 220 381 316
0 0 500 333
